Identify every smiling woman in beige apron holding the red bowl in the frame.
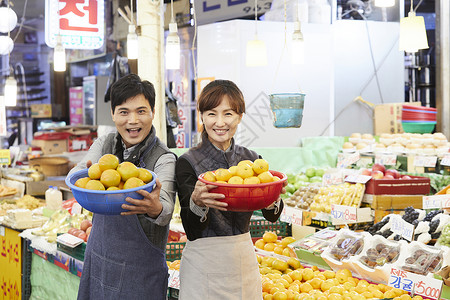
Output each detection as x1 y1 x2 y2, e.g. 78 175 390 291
175 80 284 300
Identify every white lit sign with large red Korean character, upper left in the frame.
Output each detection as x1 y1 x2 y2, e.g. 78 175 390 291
45 0 105 49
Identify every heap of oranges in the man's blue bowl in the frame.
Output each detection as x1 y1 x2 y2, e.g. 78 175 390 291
75 154 153 191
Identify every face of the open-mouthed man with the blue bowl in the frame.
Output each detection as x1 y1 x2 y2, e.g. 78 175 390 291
112 94 154 148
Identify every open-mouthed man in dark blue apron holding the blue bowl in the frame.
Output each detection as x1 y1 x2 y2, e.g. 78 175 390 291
71 74 176 300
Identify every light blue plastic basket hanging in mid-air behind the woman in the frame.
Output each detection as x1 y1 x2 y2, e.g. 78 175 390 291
269 93 305 128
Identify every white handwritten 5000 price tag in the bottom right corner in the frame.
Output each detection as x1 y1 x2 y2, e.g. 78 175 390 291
388 268 442 300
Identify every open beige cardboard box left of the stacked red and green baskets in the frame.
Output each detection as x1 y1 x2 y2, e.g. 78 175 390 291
373 102 421 135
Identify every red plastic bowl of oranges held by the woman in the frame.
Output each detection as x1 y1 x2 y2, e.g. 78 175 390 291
198 170 287 211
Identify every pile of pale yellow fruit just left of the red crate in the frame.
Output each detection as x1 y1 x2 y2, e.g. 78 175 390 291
309 182 365 213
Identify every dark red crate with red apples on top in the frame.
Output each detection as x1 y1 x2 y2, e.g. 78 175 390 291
365 176 430 195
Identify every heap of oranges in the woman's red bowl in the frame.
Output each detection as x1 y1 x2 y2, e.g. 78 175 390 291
203 158 280 184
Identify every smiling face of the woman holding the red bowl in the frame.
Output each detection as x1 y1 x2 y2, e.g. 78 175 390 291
201 95 242 151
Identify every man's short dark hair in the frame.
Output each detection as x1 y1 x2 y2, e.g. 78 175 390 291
111 74 155 113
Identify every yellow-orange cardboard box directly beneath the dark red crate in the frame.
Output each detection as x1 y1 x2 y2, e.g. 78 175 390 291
362 194 423 210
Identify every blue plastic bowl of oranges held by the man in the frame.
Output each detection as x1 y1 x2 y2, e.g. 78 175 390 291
66 169 157 215
